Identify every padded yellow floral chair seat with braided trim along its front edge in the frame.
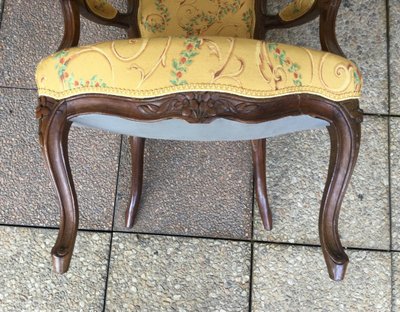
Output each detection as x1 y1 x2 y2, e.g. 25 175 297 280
36 37 362 100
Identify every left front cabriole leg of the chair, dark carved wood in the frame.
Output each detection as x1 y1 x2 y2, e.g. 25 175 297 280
38 98 79 273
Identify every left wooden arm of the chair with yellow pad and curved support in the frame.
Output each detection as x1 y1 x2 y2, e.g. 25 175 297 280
58 0 138 50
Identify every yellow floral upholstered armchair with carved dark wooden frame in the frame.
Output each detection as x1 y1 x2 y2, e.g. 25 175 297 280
36 0 362 280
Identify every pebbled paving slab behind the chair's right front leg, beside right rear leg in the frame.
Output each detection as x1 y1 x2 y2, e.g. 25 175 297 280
254 117 390 249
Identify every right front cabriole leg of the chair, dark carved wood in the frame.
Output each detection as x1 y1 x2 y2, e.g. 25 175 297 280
319 102 361 281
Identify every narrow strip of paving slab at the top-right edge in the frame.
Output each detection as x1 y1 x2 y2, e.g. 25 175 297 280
389 0 400 115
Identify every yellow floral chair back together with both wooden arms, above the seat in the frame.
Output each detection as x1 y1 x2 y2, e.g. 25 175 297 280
69 0 343 56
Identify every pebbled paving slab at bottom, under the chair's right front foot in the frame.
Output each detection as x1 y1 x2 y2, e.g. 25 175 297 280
252 244 391 312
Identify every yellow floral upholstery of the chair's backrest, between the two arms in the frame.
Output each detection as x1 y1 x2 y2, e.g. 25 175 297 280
138 0 255 38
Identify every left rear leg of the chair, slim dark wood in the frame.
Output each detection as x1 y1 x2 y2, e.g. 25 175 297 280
125 137 145 228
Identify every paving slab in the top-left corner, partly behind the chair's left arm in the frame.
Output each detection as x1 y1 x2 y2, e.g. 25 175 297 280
0 0 125 88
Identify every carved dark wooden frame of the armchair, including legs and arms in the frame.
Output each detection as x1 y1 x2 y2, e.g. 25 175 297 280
37 0 362 280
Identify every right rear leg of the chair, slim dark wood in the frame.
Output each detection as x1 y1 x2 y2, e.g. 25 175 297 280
251 139 272 231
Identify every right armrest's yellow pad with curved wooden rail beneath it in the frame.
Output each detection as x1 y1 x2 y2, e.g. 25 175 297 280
265 0 319 30
